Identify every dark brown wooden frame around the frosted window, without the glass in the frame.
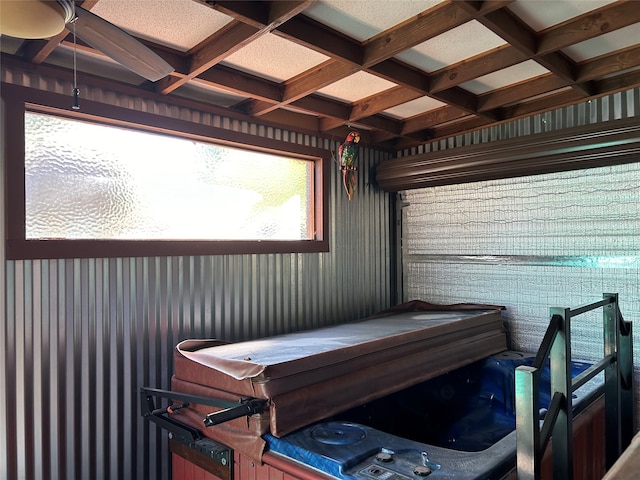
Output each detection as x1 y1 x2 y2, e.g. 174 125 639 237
1 83 330 260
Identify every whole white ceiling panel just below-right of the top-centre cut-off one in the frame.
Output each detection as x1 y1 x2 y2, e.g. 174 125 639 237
396 20 506 72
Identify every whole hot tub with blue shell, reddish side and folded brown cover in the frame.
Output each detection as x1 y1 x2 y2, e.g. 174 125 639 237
159 302 603 480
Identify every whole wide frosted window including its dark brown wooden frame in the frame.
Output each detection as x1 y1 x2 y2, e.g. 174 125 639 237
3 87 328 258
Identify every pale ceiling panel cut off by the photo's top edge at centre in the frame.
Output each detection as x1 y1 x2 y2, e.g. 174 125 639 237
304 0 443 41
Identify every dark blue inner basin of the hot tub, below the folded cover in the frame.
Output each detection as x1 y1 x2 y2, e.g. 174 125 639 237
322 352 590 452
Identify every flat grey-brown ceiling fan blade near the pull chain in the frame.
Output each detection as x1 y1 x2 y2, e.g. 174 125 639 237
73 7 174 82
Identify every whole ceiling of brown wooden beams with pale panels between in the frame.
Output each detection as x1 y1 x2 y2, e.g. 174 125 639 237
1 0 640 149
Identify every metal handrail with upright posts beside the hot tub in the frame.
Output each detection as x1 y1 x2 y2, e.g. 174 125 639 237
515 293 635 480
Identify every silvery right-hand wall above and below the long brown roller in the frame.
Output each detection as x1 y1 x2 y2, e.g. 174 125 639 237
402 89 640 426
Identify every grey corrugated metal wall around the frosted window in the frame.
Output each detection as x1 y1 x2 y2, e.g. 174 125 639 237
0 67 395 480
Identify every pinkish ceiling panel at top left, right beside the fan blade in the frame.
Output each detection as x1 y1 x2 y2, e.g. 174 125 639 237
91 0 232 52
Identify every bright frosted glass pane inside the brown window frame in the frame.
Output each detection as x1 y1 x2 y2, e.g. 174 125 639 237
25 113 314 240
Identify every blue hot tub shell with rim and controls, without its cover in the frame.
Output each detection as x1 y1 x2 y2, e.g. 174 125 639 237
266 351 602 480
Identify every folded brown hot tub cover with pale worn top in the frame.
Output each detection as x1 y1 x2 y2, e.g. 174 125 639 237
172 301 507 459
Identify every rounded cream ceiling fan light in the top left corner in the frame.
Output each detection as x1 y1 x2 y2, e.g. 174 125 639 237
0 0 74 39
